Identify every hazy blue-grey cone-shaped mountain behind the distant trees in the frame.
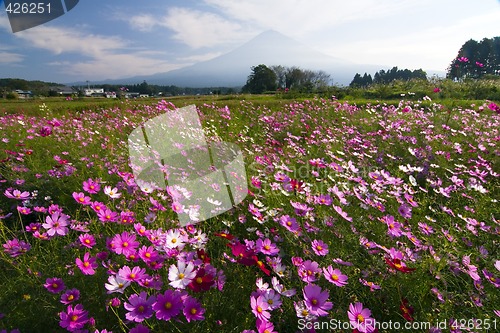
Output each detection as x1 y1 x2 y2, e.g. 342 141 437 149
97 30 380 88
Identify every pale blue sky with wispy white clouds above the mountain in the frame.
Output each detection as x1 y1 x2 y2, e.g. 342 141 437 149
0 0 500 83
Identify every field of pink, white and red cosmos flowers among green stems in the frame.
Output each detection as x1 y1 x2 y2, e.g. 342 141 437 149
0 91 500 333
